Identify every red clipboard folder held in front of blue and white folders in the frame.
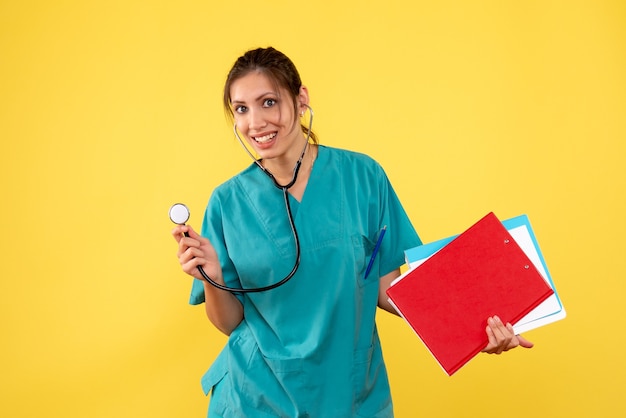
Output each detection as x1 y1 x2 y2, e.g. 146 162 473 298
387 213 554 376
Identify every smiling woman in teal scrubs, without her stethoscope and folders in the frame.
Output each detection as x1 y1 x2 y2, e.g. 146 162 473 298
173 48 531 417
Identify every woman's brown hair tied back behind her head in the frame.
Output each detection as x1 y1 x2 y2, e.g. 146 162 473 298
223 47 318 144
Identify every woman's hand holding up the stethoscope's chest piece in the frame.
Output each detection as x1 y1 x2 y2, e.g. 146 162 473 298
172 225 222 282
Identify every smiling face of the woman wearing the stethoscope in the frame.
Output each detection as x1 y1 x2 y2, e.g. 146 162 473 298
230 71 309 164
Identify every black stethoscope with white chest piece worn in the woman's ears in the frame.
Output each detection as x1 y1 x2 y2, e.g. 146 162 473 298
169 105 313 293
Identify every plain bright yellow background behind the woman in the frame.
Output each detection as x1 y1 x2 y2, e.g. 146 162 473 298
0 0 626 418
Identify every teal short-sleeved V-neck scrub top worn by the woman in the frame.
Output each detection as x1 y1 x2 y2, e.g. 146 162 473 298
190 146 421 418
